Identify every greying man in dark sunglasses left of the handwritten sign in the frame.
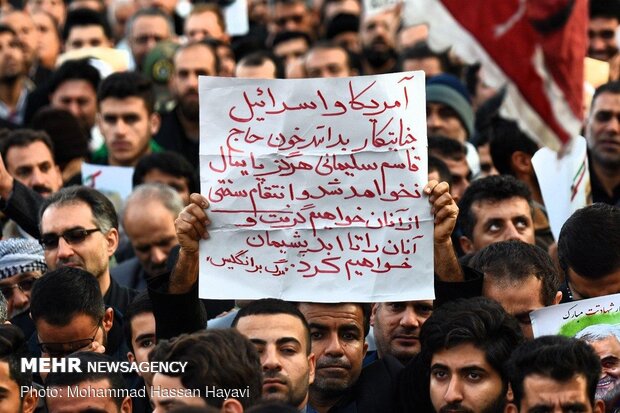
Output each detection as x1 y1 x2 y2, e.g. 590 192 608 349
40 186 136 312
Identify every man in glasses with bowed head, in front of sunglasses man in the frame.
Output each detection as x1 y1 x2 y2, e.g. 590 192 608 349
30 267 127 360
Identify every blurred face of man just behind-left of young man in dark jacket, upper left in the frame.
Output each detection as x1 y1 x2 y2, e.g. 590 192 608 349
50 79 97 131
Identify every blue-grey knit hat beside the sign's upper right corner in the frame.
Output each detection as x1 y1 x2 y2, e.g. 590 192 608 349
426 74 474 138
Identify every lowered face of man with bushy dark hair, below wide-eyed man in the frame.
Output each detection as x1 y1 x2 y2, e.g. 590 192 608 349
482 274 545 339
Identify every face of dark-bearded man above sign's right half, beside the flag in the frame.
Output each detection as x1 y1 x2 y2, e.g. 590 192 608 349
360 10 398 67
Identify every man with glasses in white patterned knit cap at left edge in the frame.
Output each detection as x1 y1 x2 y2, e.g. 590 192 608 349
0 238 47 337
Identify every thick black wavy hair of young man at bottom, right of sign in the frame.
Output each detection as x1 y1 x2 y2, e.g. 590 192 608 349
420 297 524 387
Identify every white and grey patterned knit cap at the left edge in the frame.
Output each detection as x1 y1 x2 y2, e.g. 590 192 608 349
0 238 47 280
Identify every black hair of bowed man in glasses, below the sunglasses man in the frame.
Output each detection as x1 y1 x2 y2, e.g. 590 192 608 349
30 266 105 326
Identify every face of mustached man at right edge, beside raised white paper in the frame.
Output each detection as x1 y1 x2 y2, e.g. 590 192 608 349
586 92 620 170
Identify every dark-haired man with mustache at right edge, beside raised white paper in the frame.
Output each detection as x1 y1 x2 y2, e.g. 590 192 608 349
585 81 620 206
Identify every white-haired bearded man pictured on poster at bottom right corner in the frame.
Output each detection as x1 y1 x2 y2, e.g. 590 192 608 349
575 324 620 410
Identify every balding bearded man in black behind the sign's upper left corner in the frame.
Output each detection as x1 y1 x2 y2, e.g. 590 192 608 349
155 42 219 168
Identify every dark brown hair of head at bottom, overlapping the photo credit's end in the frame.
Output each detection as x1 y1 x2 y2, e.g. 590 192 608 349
149 328 263 408
